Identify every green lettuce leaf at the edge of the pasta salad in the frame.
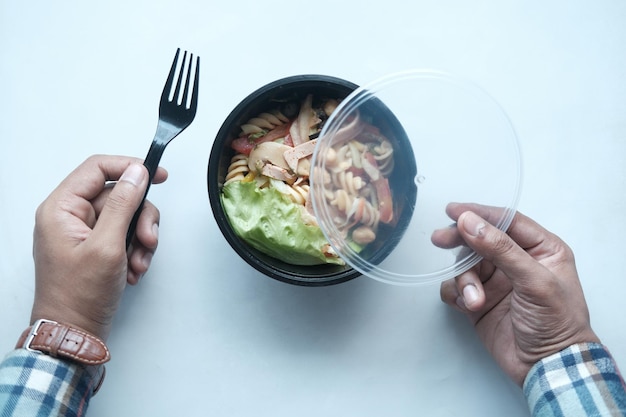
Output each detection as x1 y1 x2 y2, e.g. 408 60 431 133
221 181 344 265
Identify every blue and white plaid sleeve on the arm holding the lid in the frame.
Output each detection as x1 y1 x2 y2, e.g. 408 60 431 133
524 343 626 417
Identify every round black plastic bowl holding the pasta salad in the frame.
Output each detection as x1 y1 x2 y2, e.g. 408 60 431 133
207 75 416 286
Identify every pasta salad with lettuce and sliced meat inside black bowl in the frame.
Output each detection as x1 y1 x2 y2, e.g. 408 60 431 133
221 94 395 265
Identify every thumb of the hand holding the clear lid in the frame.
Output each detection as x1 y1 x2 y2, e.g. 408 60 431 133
457 211 545 288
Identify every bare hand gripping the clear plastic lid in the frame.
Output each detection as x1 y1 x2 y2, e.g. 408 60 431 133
432 204 599 386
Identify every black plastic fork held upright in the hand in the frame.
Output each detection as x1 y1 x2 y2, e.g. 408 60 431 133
126 48 200 248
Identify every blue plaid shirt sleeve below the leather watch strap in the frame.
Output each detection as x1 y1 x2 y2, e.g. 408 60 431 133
0 349 96 417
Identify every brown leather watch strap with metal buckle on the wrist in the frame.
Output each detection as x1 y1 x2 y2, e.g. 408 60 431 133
17 320 111 366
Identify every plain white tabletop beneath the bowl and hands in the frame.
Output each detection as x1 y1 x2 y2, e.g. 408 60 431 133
0 0 626 417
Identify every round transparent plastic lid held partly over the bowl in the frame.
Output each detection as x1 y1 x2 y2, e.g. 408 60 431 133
310 70 521 284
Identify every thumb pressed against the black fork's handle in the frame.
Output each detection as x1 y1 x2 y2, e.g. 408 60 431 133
94 164 148 244
